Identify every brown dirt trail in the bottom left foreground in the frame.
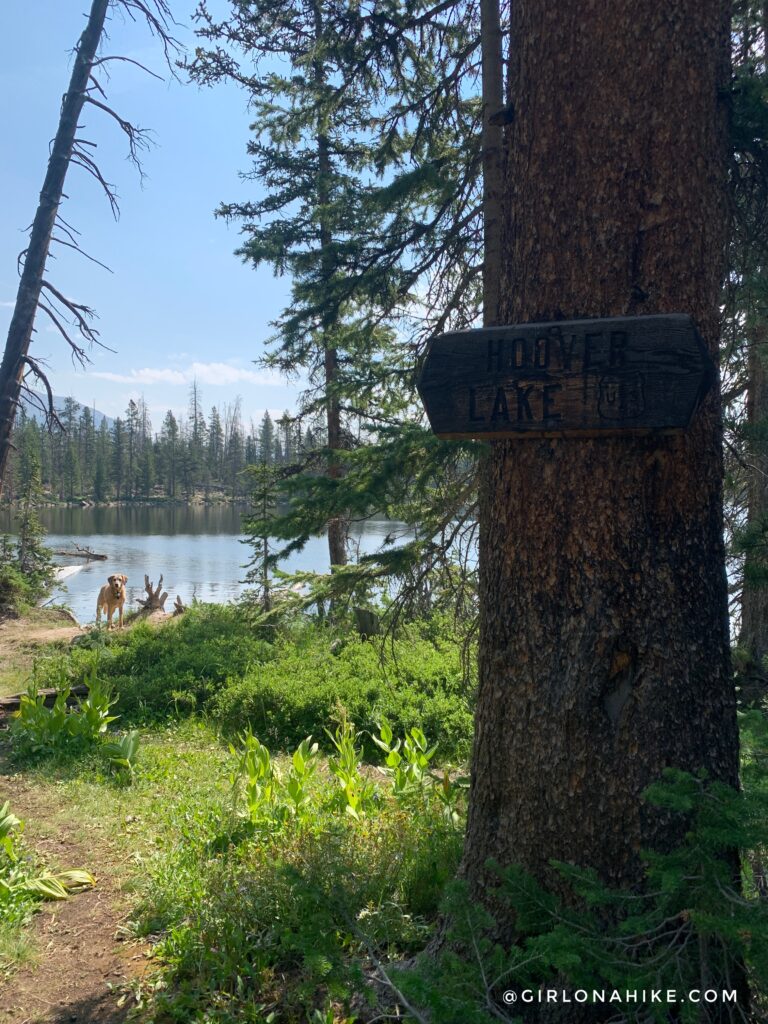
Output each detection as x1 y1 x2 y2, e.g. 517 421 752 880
0 775 148 1024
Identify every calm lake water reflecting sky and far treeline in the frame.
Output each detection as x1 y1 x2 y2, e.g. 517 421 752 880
0 505 409 623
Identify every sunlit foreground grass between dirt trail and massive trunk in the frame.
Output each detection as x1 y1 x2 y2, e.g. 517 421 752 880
1 718 461 1024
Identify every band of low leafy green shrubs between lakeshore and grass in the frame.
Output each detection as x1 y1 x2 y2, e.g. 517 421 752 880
31 605 472 761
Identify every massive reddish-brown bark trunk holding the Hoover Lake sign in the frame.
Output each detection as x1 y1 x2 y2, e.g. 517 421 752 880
464 0 737 950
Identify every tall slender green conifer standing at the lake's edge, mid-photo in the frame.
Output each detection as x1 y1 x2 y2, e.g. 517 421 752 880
189 0 409 565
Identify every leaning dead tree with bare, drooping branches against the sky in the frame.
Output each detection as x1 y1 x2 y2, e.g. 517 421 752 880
0 0 177 494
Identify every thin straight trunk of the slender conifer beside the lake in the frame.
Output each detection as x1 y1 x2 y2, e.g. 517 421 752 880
312 3 347 565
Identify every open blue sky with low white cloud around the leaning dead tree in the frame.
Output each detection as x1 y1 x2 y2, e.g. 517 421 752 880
0 0 297 430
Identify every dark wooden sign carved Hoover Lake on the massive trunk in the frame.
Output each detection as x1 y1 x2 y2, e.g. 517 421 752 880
418 313 715 438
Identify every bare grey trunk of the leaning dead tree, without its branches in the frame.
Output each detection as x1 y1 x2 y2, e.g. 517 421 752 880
0 0 110 494
